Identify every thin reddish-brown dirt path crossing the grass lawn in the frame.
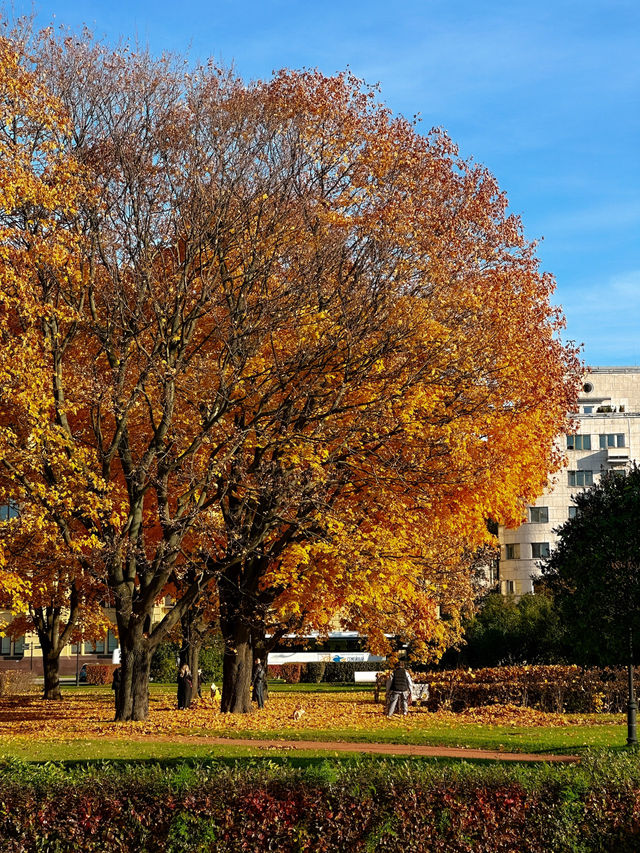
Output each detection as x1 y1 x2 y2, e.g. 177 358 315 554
130 735 580 764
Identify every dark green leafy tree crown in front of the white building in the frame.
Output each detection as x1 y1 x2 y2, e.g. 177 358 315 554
543 466 640 665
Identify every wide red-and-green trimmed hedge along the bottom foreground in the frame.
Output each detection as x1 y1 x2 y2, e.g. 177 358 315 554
0 755 640 853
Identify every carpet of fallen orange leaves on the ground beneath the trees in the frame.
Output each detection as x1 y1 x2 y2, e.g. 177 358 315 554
0 689 621 741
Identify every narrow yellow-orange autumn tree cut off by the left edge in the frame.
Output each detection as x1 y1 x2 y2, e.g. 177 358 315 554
0 31 115 699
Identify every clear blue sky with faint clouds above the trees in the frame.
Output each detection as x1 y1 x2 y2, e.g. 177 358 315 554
8 0 640 365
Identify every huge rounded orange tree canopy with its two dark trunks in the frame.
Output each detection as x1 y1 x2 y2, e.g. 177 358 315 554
1 34 578 719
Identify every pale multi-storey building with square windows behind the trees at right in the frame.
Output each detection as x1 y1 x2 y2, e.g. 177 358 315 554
498 367 640 595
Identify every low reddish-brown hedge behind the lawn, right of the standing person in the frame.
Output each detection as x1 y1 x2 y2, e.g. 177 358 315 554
414 666 637 714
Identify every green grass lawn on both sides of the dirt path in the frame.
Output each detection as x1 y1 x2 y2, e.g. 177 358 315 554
0 682 627 762
